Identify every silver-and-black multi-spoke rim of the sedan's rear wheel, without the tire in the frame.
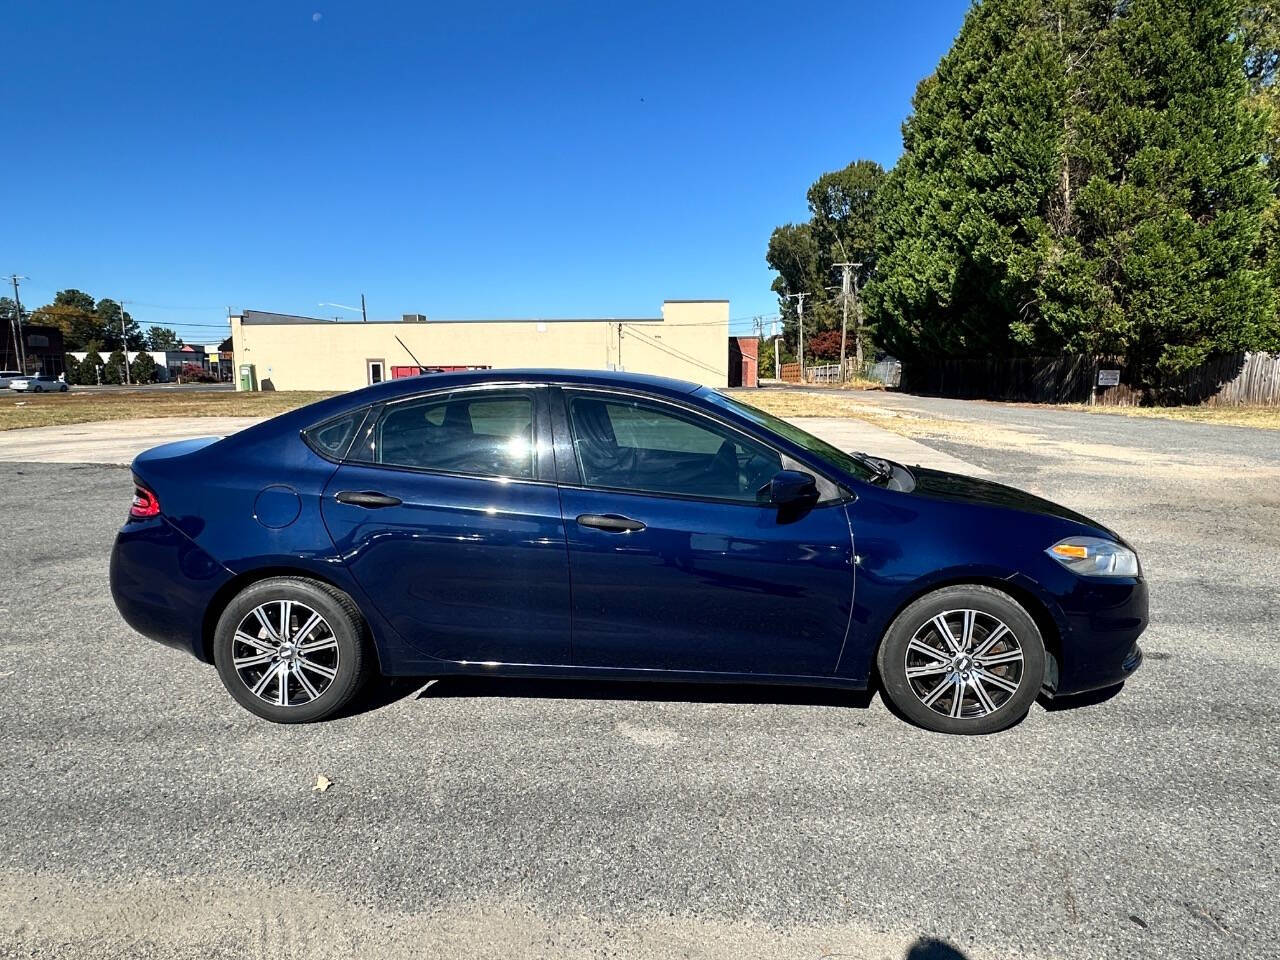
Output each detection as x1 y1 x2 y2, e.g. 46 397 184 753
232 600 339 707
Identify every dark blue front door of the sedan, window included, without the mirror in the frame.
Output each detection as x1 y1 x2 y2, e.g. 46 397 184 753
553 389 854 677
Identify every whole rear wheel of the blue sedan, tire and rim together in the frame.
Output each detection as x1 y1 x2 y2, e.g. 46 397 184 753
214 577 369 723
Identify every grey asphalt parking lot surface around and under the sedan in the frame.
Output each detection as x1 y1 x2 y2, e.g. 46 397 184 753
0 404 1280 960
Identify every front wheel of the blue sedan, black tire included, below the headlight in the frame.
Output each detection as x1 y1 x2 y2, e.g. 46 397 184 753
876 584 1044 733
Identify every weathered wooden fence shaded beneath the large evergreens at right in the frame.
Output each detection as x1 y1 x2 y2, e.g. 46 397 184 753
902 352 1280 406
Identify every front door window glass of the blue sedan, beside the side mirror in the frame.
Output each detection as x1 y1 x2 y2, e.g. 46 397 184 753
568 394 782 503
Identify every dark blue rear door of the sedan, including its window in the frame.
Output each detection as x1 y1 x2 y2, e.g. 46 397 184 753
323 385 570 664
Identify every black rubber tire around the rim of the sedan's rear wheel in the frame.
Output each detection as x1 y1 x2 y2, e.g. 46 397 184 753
214 577 371 723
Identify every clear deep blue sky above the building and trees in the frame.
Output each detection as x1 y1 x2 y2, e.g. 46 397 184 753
0 0 968 340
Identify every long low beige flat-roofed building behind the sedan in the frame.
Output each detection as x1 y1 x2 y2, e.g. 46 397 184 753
232 300 728 390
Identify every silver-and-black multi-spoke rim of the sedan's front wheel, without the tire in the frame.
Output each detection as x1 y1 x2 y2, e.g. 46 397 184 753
905 609 1024 719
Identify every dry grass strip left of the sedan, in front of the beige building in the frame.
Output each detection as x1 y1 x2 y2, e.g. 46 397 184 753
0 388 333 430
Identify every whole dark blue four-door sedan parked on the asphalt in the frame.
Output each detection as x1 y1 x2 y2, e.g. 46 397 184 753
111 370 1147 733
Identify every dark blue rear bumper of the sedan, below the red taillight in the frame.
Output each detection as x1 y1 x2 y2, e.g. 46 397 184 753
110 518 232 659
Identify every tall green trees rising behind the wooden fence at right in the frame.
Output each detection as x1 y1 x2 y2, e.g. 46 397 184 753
765 0 1280 383
